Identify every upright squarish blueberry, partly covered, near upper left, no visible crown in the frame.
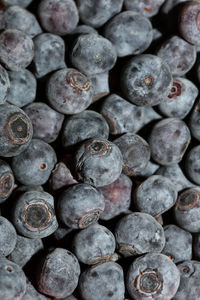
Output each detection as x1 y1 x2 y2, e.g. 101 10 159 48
33 33 66 78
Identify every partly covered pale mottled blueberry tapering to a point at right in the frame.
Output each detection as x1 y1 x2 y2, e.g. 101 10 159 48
101 94 161 135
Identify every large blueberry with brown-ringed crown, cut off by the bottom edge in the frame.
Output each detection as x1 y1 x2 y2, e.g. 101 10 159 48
126 253 180 300
